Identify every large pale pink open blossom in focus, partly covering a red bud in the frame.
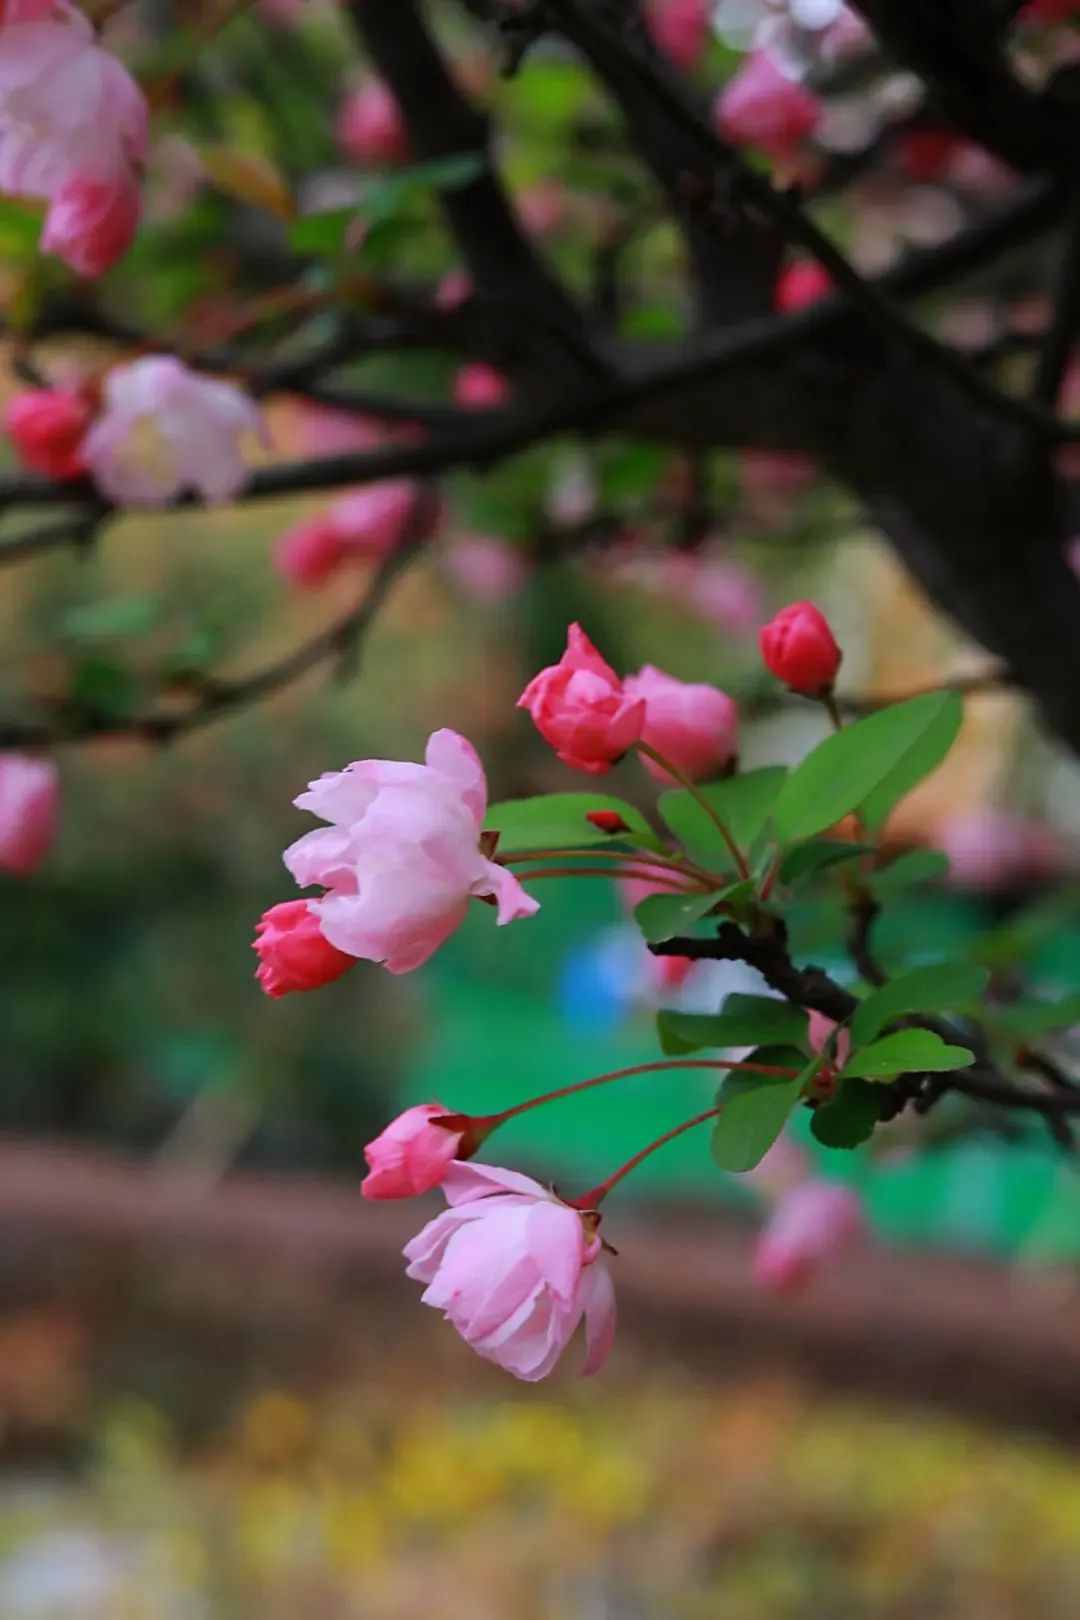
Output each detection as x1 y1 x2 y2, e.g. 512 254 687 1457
285 731 539 974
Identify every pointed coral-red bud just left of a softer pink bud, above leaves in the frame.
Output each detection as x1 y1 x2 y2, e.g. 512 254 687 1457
518 624 644 773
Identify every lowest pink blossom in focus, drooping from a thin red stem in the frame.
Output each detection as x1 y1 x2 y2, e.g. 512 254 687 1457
405 1163 615 1383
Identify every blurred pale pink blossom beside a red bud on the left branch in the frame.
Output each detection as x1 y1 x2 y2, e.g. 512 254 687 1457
84 355 262 505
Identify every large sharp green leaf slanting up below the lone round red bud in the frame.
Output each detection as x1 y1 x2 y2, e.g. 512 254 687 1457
774 692 963 842
